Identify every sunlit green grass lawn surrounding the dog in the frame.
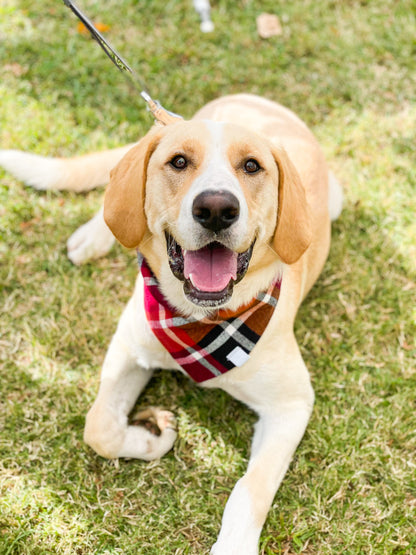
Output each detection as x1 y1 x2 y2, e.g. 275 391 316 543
0 0 416 555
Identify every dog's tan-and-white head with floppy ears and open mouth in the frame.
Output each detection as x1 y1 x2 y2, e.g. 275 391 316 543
104 120 310 308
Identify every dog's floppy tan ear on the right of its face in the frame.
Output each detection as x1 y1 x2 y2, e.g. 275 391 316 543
273 148 312 264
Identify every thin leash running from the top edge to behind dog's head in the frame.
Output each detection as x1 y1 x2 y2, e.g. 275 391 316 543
63 0 183 125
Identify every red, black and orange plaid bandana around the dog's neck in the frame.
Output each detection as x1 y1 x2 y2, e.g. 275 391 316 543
139 255 281 383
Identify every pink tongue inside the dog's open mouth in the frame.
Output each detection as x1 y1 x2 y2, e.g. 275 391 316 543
183 245 237 292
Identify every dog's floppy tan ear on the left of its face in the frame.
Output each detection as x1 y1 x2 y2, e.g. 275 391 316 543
104 130 161 248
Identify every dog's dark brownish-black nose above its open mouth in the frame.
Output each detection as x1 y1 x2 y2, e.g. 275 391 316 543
192 191 240 232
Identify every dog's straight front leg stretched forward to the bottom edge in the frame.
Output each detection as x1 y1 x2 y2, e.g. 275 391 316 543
211 348 314 555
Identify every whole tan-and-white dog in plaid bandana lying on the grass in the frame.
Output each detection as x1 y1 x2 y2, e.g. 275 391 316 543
0 94 342 555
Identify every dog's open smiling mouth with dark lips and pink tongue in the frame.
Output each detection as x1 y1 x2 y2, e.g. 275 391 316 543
166 233 254 308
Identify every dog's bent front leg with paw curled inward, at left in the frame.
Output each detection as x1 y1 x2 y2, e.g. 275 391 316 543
84 297 177 461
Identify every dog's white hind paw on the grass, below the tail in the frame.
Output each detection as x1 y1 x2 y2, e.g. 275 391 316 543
66 210 114 266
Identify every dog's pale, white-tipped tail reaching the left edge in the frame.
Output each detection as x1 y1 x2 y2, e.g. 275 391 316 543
0 144 134 193
